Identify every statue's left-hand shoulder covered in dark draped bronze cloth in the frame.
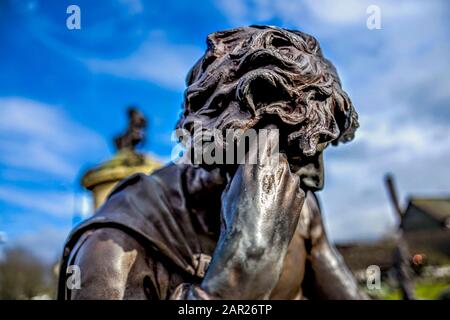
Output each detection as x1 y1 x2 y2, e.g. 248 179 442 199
62 164 201 290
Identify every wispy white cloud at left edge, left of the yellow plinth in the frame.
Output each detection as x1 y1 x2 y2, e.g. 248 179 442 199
0 97 107 181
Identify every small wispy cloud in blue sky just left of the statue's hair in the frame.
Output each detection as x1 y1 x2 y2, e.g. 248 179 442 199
85 34 203 90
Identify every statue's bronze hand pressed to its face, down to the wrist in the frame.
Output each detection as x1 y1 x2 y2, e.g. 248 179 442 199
222 132 305 254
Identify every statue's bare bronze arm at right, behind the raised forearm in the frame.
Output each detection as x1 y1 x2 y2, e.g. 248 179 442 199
307 196 367 300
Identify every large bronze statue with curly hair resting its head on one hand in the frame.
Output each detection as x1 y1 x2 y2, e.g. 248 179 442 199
59 26 366 300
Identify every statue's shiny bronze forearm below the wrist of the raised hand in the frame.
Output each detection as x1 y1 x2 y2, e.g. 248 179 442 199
174 229 287 300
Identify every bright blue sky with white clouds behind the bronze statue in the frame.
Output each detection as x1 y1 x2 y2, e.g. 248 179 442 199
0 0 450 260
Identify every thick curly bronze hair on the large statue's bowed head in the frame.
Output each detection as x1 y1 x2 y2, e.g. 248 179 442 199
177 26 358 156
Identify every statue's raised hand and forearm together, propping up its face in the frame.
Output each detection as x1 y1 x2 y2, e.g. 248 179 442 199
201 128 305 299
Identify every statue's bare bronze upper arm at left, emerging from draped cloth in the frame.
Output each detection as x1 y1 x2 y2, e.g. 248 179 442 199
68 228 149 300
